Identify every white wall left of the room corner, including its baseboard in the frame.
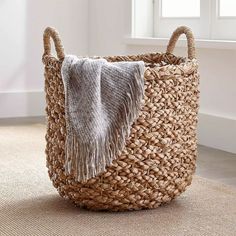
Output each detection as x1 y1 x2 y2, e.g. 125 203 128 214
0 0 88 117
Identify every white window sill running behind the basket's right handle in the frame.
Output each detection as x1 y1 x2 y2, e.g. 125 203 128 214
124 37 236 50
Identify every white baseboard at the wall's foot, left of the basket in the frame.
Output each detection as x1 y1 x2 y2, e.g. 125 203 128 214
0 90 45 118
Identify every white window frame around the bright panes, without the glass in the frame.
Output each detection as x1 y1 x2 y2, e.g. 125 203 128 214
153 0 236 41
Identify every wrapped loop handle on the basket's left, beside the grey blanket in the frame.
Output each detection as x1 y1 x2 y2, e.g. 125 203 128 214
43 27 65 60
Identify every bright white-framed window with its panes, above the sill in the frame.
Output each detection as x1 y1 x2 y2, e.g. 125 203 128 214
133 0 236 40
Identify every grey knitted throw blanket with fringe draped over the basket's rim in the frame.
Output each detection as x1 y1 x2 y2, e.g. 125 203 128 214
61 55 144 182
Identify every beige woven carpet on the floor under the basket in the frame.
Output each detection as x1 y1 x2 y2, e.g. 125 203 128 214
0 125 236 236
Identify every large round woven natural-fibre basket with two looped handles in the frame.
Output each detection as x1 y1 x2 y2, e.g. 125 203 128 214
43 26 199 211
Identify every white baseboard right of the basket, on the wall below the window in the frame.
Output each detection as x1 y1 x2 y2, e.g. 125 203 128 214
198 113 236 153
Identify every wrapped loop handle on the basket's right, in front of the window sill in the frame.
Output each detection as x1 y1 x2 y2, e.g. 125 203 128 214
166 26 196 60
